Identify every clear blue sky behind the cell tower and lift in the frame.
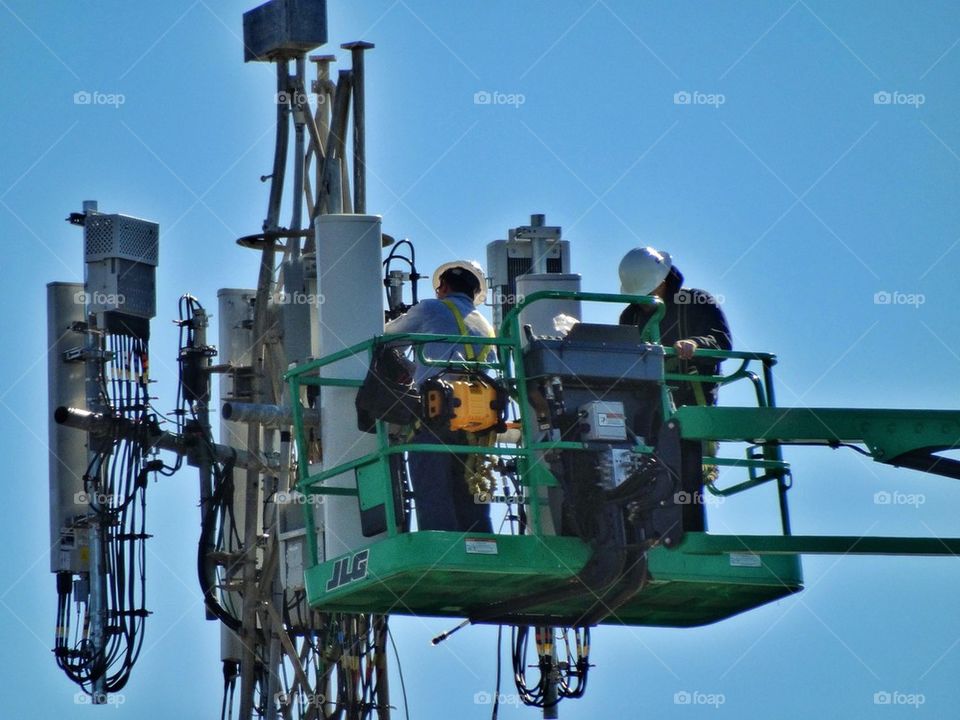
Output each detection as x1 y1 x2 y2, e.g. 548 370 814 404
0 0 960 718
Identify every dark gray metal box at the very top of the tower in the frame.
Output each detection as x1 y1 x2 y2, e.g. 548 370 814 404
243 0 327 62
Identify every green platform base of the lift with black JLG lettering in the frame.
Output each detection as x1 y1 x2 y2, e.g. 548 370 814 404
306 531 803 627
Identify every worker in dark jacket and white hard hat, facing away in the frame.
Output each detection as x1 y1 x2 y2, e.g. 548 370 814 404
620 247 732 530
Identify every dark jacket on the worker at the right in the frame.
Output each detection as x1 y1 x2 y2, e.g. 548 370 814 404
620 267 732 407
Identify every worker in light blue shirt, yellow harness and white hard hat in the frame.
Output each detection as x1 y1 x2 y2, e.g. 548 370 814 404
384 260 494 532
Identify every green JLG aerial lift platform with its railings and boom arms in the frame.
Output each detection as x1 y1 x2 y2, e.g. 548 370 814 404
286 291 960 627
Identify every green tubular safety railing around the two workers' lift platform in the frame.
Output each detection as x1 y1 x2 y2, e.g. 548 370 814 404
284 290 789 565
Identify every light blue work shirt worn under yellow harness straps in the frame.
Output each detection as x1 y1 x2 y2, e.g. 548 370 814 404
383 293 494 385
